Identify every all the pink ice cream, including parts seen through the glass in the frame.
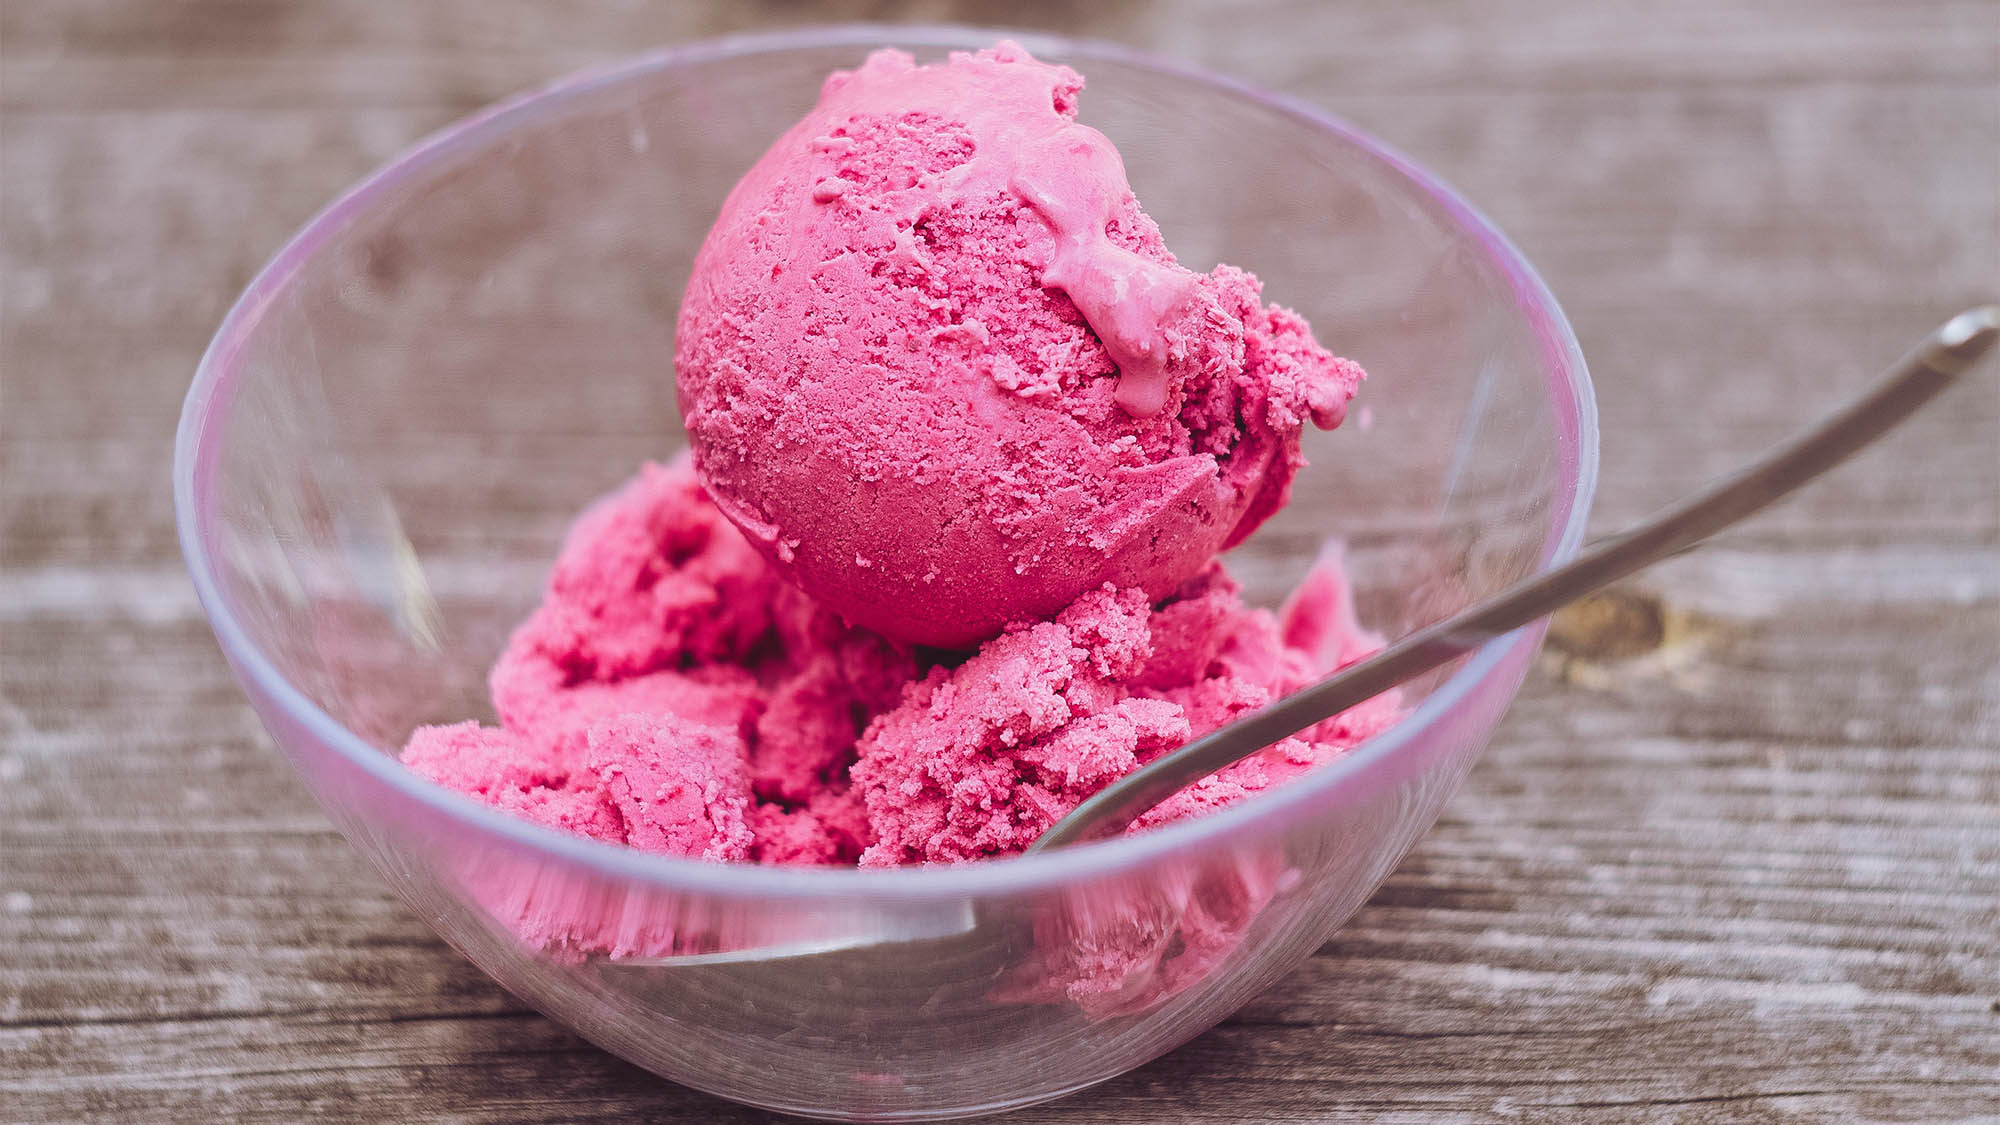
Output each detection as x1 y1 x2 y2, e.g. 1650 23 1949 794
404 44 1400 1017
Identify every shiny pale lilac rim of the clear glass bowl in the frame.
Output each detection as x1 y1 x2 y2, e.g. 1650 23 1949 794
174 24 1598 899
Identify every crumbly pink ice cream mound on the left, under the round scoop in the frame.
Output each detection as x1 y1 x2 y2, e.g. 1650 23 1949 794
404 462 918 863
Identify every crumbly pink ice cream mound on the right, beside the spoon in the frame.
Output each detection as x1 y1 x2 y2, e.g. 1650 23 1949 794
850 565 1396 867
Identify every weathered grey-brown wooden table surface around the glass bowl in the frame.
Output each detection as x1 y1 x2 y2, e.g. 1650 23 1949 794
0 0 2000 1123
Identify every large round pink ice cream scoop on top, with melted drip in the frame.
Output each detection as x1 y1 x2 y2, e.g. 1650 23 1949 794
674 42 1362 649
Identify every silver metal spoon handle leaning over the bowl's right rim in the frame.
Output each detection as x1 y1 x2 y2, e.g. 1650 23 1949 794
1028 304 2000 853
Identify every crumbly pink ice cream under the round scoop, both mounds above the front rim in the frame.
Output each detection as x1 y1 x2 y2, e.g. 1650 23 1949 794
404 462 1398 867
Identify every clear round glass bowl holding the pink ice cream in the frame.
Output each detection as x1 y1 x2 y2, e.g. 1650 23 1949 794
174 26 1596 1119
